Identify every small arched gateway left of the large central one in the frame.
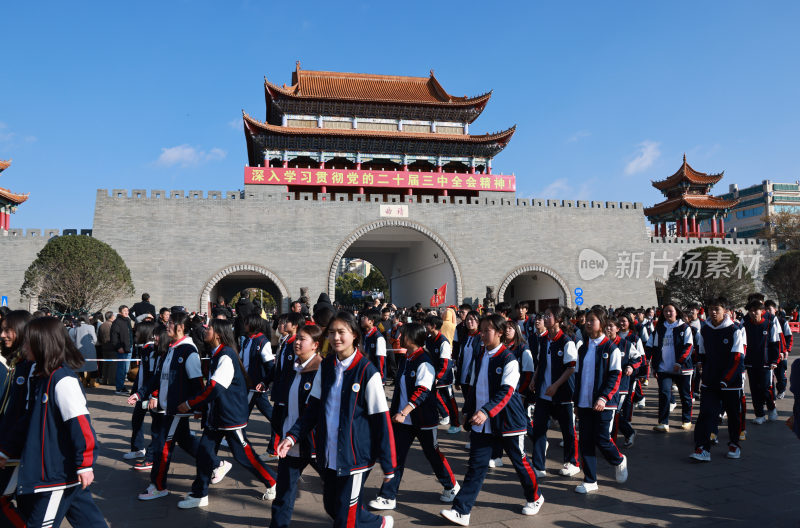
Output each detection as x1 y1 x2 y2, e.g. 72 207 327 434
200 263 289 312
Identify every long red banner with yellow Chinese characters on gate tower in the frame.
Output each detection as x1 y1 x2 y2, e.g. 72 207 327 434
244 167 517 192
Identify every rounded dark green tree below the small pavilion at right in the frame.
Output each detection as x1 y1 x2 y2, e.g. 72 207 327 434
666 246 755 307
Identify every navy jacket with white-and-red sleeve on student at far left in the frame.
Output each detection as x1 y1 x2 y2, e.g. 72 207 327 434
17 367 97 494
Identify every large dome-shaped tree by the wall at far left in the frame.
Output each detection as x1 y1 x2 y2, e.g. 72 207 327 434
20 235 135 313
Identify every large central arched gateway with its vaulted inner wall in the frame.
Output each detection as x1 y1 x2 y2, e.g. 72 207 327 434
328 219 462 306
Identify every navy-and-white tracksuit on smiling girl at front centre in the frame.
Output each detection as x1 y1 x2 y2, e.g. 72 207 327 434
286 350 397 528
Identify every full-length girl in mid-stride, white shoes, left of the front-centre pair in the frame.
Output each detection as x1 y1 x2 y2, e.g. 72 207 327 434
178 320 275 509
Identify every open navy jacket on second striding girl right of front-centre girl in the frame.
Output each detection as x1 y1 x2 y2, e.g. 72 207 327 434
464 346 528 436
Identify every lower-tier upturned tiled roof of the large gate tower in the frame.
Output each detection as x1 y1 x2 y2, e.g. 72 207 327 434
242 110 517 144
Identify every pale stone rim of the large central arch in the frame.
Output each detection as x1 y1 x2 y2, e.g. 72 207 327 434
328 218 463 304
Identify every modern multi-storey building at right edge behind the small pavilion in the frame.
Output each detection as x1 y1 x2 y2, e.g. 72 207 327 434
718 180 800 238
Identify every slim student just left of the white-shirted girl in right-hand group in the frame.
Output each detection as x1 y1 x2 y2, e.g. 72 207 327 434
612 312 645 447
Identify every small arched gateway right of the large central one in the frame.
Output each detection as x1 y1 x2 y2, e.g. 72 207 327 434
497 264 572 312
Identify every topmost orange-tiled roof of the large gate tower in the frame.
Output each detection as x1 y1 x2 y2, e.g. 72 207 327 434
264 62 492 106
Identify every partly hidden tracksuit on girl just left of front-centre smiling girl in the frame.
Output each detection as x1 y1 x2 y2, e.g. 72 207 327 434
270 354 322 528
